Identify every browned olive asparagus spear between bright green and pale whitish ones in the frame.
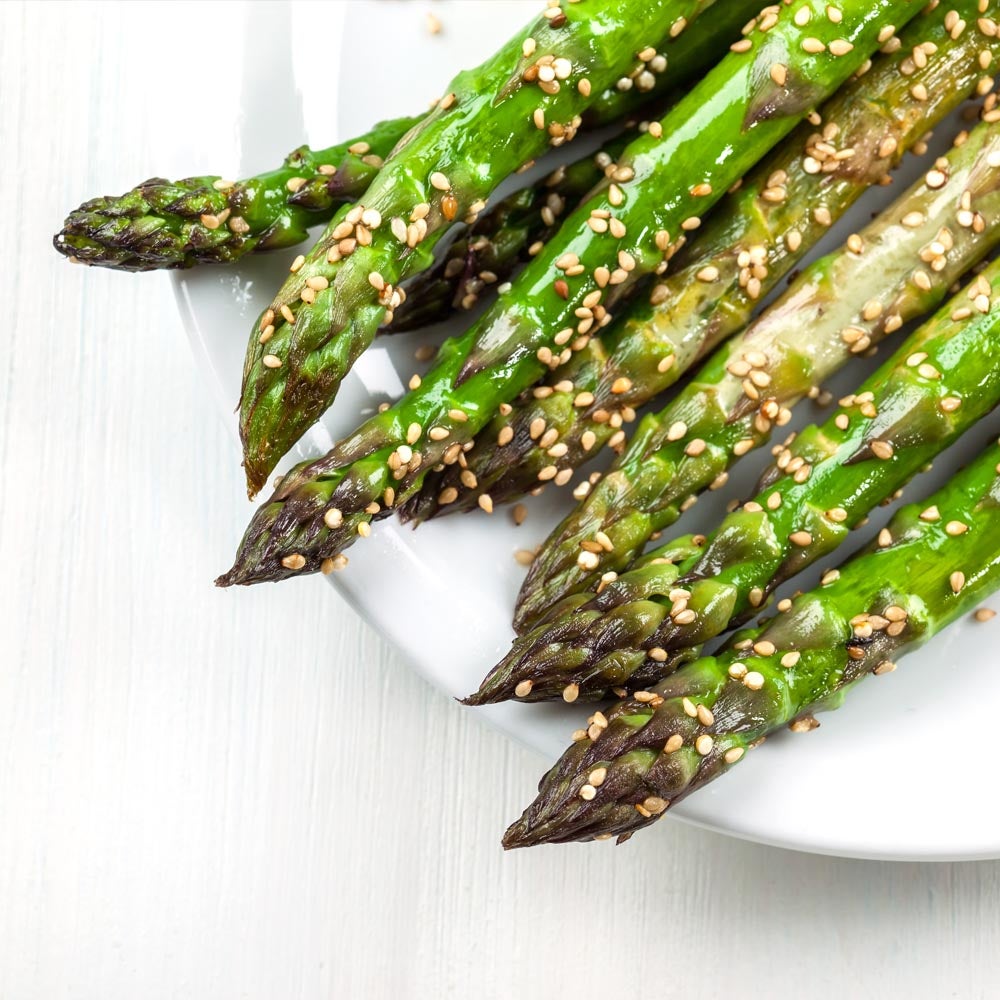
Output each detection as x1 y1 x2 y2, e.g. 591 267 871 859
399 0 1000 524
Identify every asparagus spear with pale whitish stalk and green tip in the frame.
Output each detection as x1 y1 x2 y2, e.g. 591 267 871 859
515 107 1000 631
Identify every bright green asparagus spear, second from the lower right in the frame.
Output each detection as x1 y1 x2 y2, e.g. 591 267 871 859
478 262 1000 703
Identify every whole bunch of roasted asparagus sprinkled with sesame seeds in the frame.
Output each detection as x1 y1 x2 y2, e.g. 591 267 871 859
55 0 1000 847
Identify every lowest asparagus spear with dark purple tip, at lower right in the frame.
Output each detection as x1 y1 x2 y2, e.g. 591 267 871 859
503 447 1000 848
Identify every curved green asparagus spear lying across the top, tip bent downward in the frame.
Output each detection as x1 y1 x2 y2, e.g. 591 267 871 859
240 0 772 496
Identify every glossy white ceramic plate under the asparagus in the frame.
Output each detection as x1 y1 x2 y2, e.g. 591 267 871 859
175 0 1000 860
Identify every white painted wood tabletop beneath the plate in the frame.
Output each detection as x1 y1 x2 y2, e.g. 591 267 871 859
0 2 1000 1000
